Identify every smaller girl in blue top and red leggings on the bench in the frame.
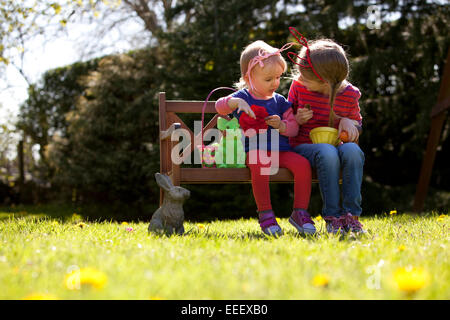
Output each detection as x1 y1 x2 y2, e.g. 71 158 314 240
216 41 316 236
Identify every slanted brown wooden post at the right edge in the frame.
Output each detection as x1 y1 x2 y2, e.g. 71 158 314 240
413 49 450 212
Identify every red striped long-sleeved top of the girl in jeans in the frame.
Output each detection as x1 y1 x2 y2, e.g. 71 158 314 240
289 80 362 147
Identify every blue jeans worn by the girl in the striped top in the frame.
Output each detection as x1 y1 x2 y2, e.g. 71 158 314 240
294 143 364 217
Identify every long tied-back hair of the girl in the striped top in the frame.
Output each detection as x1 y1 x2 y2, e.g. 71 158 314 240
297 39 350 126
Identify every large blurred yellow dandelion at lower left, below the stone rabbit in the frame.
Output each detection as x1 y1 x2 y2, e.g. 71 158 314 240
64 268 107 290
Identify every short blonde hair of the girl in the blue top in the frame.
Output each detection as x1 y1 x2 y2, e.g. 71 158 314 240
234 40 287 90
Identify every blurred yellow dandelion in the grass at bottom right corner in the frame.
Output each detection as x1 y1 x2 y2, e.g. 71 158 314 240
394 267 429 294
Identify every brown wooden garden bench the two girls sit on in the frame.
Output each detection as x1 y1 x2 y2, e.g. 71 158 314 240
159 92 317 203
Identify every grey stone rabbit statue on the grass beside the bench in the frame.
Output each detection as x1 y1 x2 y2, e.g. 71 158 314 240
148 173 191 235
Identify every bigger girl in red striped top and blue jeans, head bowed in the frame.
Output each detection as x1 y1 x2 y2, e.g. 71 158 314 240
289 29 365 233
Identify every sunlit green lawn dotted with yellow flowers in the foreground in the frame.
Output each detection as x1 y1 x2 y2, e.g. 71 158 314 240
0 211 450 299
